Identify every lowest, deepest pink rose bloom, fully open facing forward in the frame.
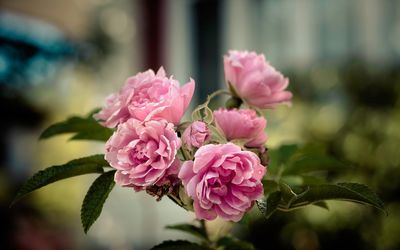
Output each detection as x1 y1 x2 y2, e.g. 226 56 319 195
178 143 266 221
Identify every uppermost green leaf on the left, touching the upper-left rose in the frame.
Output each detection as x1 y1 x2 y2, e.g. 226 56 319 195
40 112 113 141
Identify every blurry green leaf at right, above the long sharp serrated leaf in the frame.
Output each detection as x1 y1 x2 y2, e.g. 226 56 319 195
283 153 348 175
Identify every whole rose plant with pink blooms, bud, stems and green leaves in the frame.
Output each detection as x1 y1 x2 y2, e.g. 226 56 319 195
14 51 384 249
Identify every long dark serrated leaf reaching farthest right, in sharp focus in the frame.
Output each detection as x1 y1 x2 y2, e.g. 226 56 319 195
284 183 385 211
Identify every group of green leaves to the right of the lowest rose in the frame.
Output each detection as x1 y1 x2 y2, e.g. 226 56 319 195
257 145 385 218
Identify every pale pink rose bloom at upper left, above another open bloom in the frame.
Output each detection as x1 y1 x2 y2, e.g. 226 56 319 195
95 67 195 128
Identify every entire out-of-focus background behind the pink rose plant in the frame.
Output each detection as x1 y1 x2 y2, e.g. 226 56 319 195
0 0 400 250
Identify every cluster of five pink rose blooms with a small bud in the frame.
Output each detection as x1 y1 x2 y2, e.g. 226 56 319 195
95 51 292 221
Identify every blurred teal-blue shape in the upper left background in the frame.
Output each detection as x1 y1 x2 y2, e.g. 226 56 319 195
0 11 77 88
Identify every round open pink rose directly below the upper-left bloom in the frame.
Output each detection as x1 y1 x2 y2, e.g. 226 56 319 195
105 119 181 191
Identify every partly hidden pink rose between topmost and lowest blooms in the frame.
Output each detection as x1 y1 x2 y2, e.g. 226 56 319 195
214 109 268 147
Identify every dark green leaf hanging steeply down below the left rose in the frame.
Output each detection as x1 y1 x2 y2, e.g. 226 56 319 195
81 170 115 233
